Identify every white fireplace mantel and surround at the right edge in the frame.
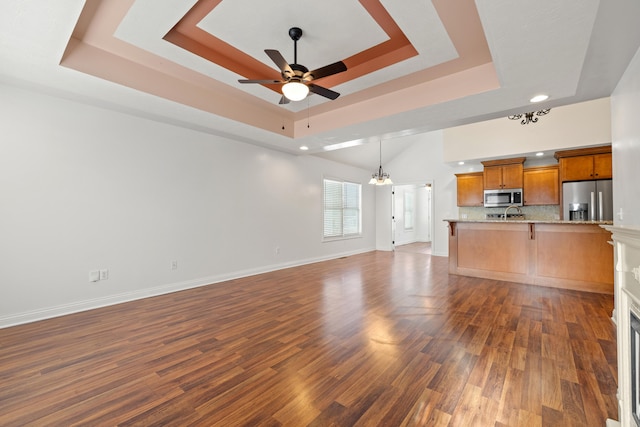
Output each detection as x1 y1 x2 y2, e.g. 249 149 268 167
602 225 640 427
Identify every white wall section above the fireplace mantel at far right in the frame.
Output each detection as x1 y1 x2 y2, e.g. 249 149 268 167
611 46 640 227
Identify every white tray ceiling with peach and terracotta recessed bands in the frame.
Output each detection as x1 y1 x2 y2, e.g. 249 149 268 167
0 0 640 171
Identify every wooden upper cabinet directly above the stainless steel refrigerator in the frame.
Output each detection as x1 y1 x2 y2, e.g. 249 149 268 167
555 145 613 182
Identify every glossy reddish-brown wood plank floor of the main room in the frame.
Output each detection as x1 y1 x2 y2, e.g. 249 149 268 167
0 252 617 427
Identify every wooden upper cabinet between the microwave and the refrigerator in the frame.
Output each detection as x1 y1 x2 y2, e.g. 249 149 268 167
522 165 560 206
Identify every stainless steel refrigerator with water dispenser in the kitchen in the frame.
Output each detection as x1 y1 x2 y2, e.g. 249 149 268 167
562 179 613 221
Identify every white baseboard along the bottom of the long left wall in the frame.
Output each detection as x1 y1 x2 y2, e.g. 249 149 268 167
0 248 375 329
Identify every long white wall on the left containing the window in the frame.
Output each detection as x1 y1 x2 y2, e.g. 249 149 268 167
0 85 376 327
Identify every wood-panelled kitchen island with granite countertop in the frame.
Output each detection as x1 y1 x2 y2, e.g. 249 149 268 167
445 219 613 294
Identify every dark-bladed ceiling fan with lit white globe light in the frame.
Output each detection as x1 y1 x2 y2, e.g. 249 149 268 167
238 27 347 104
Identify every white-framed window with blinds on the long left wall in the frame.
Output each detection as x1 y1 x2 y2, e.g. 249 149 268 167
323 179 362 239
